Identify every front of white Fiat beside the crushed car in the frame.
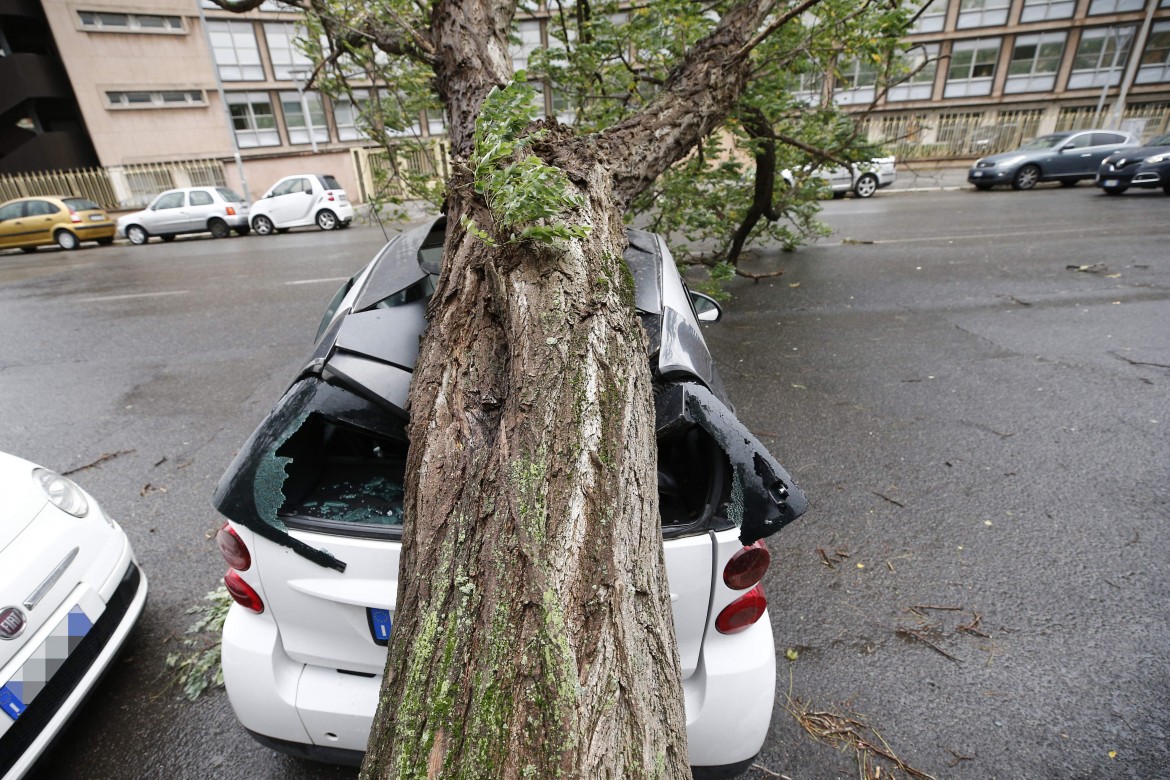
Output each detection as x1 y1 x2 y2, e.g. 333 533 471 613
0 453 146 780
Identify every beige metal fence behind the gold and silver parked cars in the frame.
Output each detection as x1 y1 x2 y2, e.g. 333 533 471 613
0 160 227 209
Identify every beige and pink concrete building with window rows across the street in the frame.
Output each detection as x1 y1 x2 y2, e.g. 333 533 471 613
0 0 1170 206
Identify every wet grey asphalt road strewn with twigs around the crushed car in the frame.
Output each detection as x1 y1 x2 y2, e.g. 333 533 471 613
0 186 1170 780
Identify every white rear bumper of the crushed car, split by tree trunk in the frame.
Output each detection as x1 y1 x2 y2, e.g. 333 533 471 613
222 606 776 776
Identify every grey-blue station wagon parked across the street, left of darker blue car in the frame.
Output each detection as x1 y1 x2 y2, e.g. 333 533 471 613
966 130 1138 189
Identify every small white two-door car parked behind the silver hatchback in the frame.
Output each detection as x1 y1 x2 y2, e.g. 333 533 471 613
252 173 353 235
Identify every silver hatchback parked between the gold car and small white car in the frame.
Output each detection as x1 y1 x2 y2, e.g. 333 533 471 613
118 187 250 244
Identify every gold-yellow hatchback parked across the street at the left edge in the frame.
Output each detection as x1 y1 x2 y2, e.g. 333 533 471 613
0 196 115 251
